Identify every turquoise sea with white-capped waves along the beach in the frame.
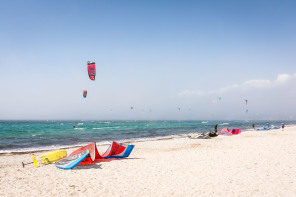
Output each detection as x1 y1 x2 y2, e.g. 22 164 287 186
0 120 296 154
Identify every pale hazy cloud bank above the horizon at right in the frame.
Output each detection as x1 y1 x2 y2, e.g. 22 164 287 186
179 74 296 119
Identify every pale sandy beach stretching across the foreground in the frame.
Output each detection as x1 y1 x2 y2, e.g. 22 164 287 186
0 127 296 196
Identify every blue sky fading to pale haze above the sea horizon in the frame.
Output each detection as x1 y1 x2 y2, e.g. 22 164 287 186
0 0 296 120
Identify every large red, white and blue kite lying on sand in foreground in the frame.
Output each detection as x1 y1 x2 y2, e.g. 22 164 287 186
56 142 134 170
